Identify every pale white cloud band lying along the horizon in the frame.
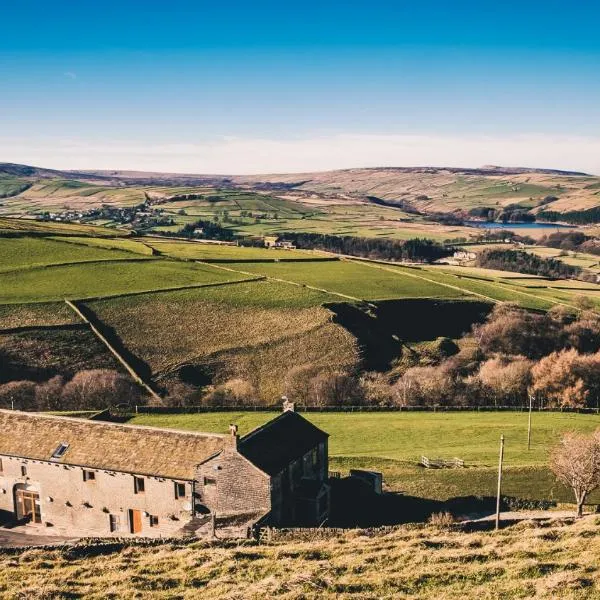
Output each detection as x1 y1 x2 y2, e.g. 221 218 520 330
0 134 600 174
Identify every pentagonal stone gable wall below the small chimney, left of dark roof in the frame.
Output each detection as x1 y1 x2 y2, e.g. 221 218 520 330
196 445 271 515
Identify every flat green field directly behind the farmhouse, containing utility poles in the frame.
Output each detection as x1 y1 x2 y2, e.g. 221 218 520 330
132 411 600 502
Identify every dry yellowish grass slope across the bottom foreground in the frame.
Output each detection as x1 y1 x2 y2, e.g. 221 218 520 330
0 516 600 600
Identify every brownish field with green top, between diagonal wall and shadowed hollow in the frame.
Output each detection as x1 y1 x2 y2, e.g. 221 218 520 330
88 281 358 397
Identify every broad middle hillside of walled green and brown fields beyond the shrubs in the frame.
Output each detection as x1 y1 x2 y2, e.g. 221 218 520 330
0 219 600 404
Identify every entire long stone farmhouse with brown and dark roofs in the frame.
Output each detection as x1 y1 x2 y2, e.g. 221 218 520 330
0 403 329 537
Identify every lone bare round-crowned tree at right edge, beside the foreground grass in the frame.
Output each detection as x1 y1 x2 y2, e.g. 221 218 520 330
550 432 600 517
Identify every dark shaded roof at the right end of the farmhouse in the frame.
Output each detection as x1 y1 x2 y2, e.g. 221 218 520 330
238 411 329 475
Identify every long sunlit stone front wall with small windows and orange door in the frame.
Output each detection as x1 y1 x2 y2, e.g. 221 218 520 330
0 456 193 537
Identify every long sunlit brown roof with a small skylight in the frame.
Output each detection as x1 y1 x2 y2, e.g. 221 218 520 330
0 410 226 480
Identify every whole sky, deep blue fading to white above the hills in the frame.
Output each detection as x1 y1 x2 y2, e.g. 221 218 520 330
0 0 600 174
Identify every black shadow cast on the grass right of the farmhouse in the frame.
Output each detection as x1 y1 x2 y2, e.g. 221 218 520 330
328 477 496 527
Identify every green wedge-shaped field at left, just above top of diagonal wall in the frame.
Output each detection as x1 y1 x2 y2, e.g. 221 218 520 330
0 258 246 303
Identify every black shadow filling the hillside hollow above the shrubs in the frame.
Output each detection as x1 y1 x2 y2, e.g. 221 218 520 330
325 298 492 371
